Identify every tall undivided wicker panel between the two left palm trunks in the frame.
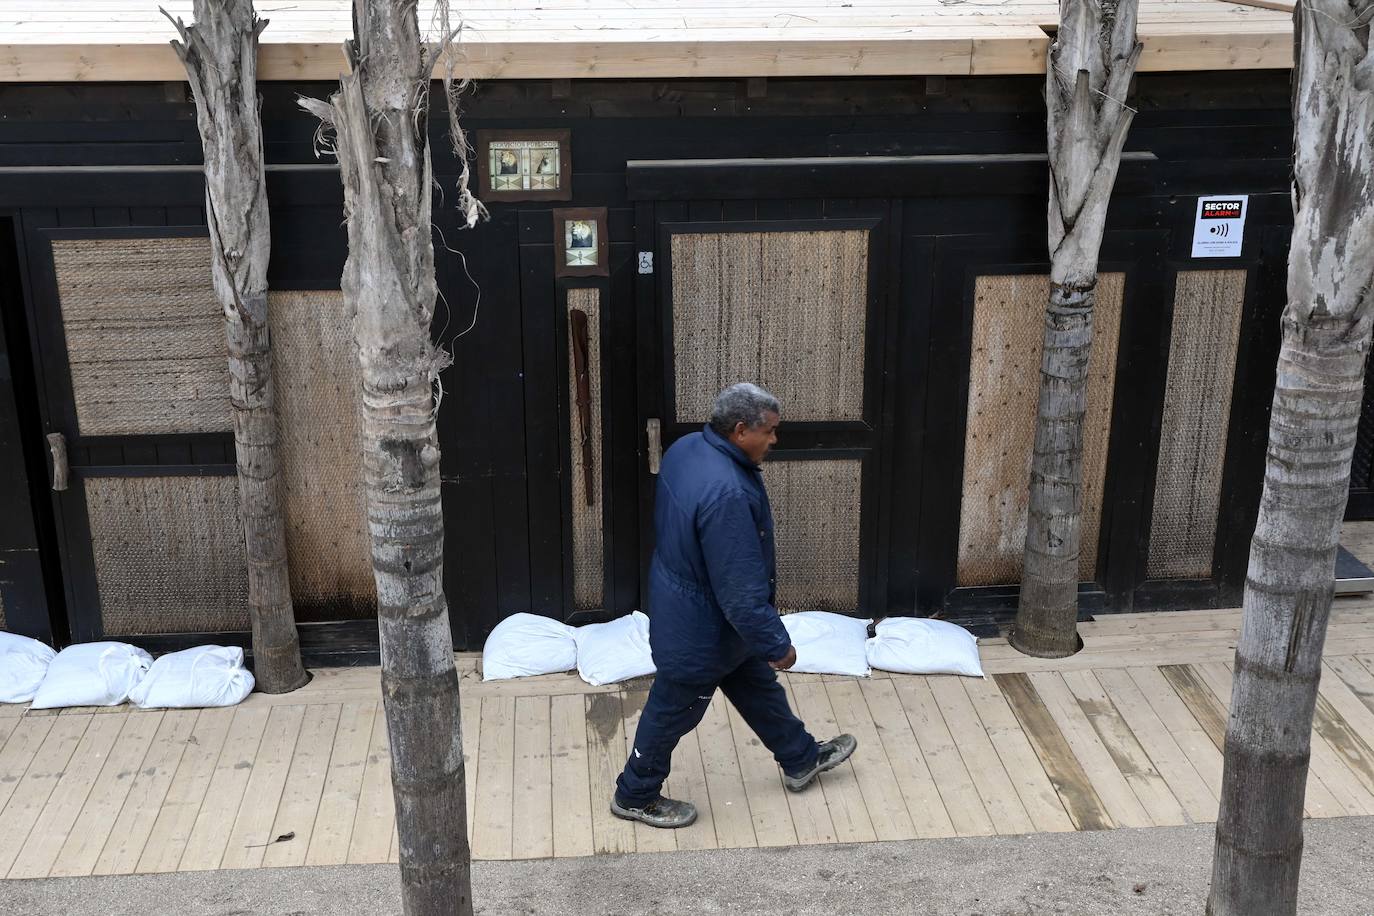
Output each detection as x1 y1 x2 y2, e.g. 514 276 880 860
269 291 376 622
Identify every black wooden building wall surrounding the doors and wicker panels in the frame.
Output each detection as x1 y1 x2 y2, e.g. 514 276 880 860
0 71 1290 659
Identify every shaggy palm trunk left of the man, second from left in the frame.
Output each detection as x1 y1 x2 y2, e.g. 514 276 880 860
302 0 473 916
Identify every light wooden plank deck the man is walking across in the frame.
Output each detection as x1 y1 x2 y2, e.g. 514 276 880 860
0 599 1374 879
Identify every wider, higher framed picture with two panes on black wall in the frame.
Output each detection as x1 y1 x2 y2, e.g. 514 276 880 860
477 129 573 201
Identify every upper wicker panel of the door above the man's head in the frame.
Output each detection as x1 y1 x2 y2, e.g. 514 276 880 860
672 229 868 422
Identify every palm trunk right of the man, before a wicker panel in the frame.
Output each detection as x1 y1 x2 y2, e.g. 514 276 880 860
1010 0 1140 658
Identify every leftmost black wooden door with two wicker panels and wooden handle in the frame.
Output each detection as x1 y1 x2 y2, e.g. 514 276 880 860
25 219 239 641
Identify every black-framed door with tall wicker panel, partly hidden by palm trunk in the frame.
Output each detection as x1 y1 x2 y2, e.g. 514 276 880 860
912 232 1167 622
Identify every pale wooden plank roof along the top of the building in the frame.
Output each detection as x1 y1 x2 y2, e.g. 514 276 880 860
0 0 1293 82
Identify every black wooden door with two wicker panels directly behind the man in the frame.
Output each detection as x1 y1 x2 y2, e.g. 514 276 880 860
638 201 893 614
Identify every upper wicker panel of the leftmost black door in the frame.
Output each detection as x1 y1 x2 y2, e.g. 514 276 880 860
52 239 232 435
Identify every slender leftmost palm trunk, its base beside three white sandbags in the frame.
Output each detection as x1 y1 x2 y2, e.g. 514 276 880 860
172 0 309 694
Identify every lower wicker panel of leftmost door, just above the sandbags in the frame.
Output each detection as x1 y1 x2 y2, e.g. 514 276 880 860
84 477 249 636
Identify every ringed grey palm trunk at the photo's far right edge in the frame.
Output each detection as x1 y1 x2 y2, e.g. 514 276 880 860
1206 0 1374 916
